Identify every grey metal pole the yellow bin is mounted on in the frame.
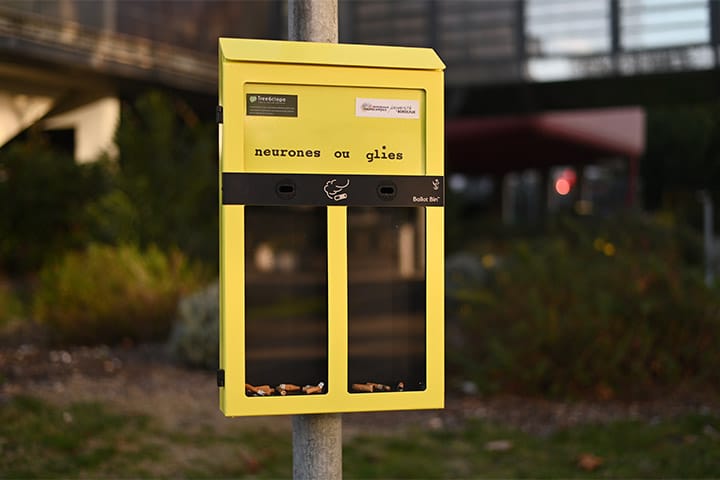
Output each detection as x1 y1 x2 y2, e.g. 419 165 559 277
288 0 342 480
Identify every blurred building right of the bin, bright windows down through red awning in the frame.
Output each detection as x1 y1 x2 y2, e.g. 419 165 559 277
341 0 720 219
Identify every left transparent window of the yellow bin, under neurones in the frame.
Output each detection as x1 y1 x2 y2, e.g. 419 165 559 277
245 207 328 396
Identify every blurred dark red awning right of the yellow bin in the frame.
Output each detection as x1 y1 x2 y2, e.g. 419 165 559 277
445 107 645 174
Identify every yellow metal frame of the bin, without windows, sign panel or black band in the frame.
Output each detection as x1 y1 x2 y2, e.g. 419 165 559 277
219 39 445 416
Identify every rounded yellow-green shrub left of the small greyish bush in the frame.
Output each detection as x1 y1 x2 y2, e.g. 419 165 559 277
34 245 198 343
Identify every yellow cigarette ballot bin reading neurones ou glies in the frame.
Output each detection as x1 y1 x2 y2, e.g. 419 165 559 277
218 38 444 416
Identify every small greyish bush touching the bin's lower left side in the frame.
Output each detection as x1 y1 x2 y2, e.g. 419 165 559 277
168 283 220 369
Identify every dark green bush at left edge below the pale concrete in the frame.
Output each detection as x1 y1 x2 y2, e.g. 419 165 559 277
0 135 107 274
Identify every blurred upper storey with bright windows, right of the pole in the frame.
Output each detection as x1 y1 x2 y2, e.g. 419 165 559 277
348 0 720 94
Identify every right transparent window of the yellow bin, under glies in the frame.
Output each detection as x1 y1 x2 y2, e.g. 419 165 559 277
348 207 426 393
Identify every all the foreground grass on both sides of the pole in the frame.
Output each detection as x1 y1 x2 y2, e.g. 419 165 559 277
0 397 720 479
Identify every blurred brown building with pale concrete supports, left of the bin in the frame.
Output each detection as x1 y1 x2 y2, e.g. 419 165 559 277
0 0 283 162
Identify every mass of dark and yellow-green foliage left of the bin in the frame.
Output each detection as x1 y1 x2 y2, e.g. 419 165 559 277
0 91 218 343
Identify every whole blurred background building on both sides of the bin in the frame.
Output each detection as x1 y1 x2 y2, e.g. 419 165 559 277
0 0 720 215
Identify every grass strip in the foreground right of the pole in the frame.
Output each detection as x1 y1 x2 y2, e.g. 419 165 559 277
345 415 720 478
